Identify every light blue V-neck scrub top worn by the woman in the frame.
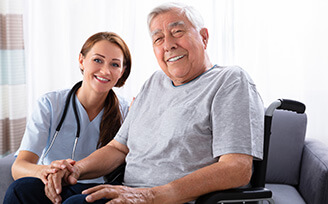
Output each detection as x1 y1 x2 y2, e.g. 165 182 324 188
16 89 129 183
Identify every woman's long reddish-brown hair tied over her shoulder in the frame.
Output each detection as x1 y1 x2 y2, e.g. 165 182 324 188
80 32 131 148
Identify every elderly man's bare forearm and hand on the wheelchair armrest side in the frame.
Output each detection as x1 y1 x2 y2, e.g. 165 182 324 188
83 154 253 204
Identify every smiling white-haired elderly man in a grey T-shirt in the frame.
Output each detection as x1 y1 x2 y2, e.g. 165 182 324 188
7 1 264 204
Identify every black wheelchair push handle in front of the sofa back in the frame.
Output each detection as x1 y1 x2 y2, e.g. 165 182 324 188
265 99 305 116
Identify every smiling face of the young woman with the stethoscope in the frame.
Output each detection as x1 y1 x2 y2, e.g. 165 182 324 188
79 40 124 94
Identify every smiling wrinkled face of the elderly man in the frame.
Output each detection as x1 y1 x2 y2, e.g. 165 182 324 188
150 9 208 86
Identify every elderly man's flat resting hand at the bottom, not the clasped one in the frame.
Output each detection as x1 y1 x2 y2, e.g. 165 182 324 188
82 185 154 204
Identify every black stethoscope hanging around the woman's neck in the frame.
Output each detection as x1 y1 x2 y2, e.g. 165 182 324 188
40 81 82 164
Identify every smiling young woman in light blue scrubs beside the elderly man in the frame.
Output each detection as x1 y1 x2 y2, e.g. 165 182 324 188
8 32 131 185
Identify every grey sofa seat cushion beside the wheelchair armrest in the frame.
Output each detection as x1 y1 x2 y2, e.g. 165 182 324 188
265 184 306 204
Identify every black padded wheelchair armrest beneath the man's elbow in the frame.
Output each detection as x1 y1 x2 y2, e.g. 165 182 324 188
196 188 272 204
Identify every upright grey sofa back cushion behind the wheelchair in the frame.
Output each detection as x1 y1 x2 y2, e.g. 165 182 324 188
266 110 307 185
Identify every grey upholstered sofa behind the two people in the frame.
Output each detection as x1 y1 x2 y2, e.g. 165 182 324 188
0 110 328 204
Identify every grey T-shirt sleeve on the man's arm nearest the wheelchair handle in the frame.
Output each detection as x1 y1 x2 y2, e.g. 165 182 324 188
211 69 264 159
